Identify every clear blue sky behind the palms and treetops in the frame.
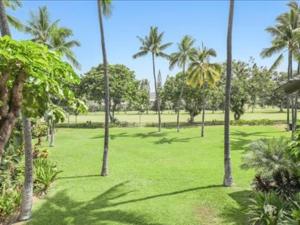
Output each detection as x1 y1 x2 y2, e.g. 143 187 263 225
9 0 287 89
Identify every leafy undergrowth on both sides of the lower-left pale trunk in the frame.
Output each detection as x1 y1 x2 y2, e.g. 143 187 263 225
0 129 59 224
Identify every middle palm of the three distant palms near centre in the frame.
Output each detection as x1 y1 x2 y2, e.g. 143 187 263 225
170 35 196 132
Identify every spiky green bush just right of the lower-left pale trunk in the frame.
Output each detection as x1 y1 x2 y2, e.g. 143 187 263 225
34 158 61 195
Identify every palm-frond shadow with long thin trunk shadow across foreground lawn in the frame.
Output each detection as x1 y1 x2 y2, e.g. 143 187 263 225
27 181 222 225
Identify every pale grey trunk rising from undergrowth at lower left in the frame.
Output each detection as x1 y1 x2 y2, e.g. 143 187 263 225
19 116 33 221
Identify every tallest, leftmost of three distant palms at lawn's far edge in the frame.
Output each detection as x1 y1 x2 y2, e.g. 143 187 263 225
133 27 172 132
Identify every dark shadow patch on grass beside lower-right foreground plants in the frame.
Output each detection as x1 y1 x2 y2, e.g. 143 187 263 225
221 190 252 225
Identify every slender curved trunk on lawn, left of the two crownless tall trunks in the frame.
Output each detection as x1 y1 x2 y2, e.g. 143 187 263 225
97 0 109 176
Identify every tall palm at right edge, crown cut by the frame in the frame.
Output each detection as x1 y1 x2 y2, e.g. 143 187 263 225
261 1 300 126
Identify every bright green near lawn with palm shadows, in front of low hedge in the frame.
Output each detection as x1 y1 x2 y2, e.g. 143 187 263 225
28 126 285 225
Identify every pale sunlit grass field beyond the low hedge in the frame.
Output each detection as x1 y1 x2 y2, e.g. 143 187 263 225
66 108 286 123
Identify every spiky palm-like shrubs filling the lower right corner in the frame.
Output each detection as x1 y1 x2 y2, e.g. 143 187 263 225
242 135 300 225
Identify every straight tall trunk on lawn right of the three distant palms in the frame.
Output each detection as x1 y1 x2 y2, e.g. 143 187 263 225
223 0 234 187
